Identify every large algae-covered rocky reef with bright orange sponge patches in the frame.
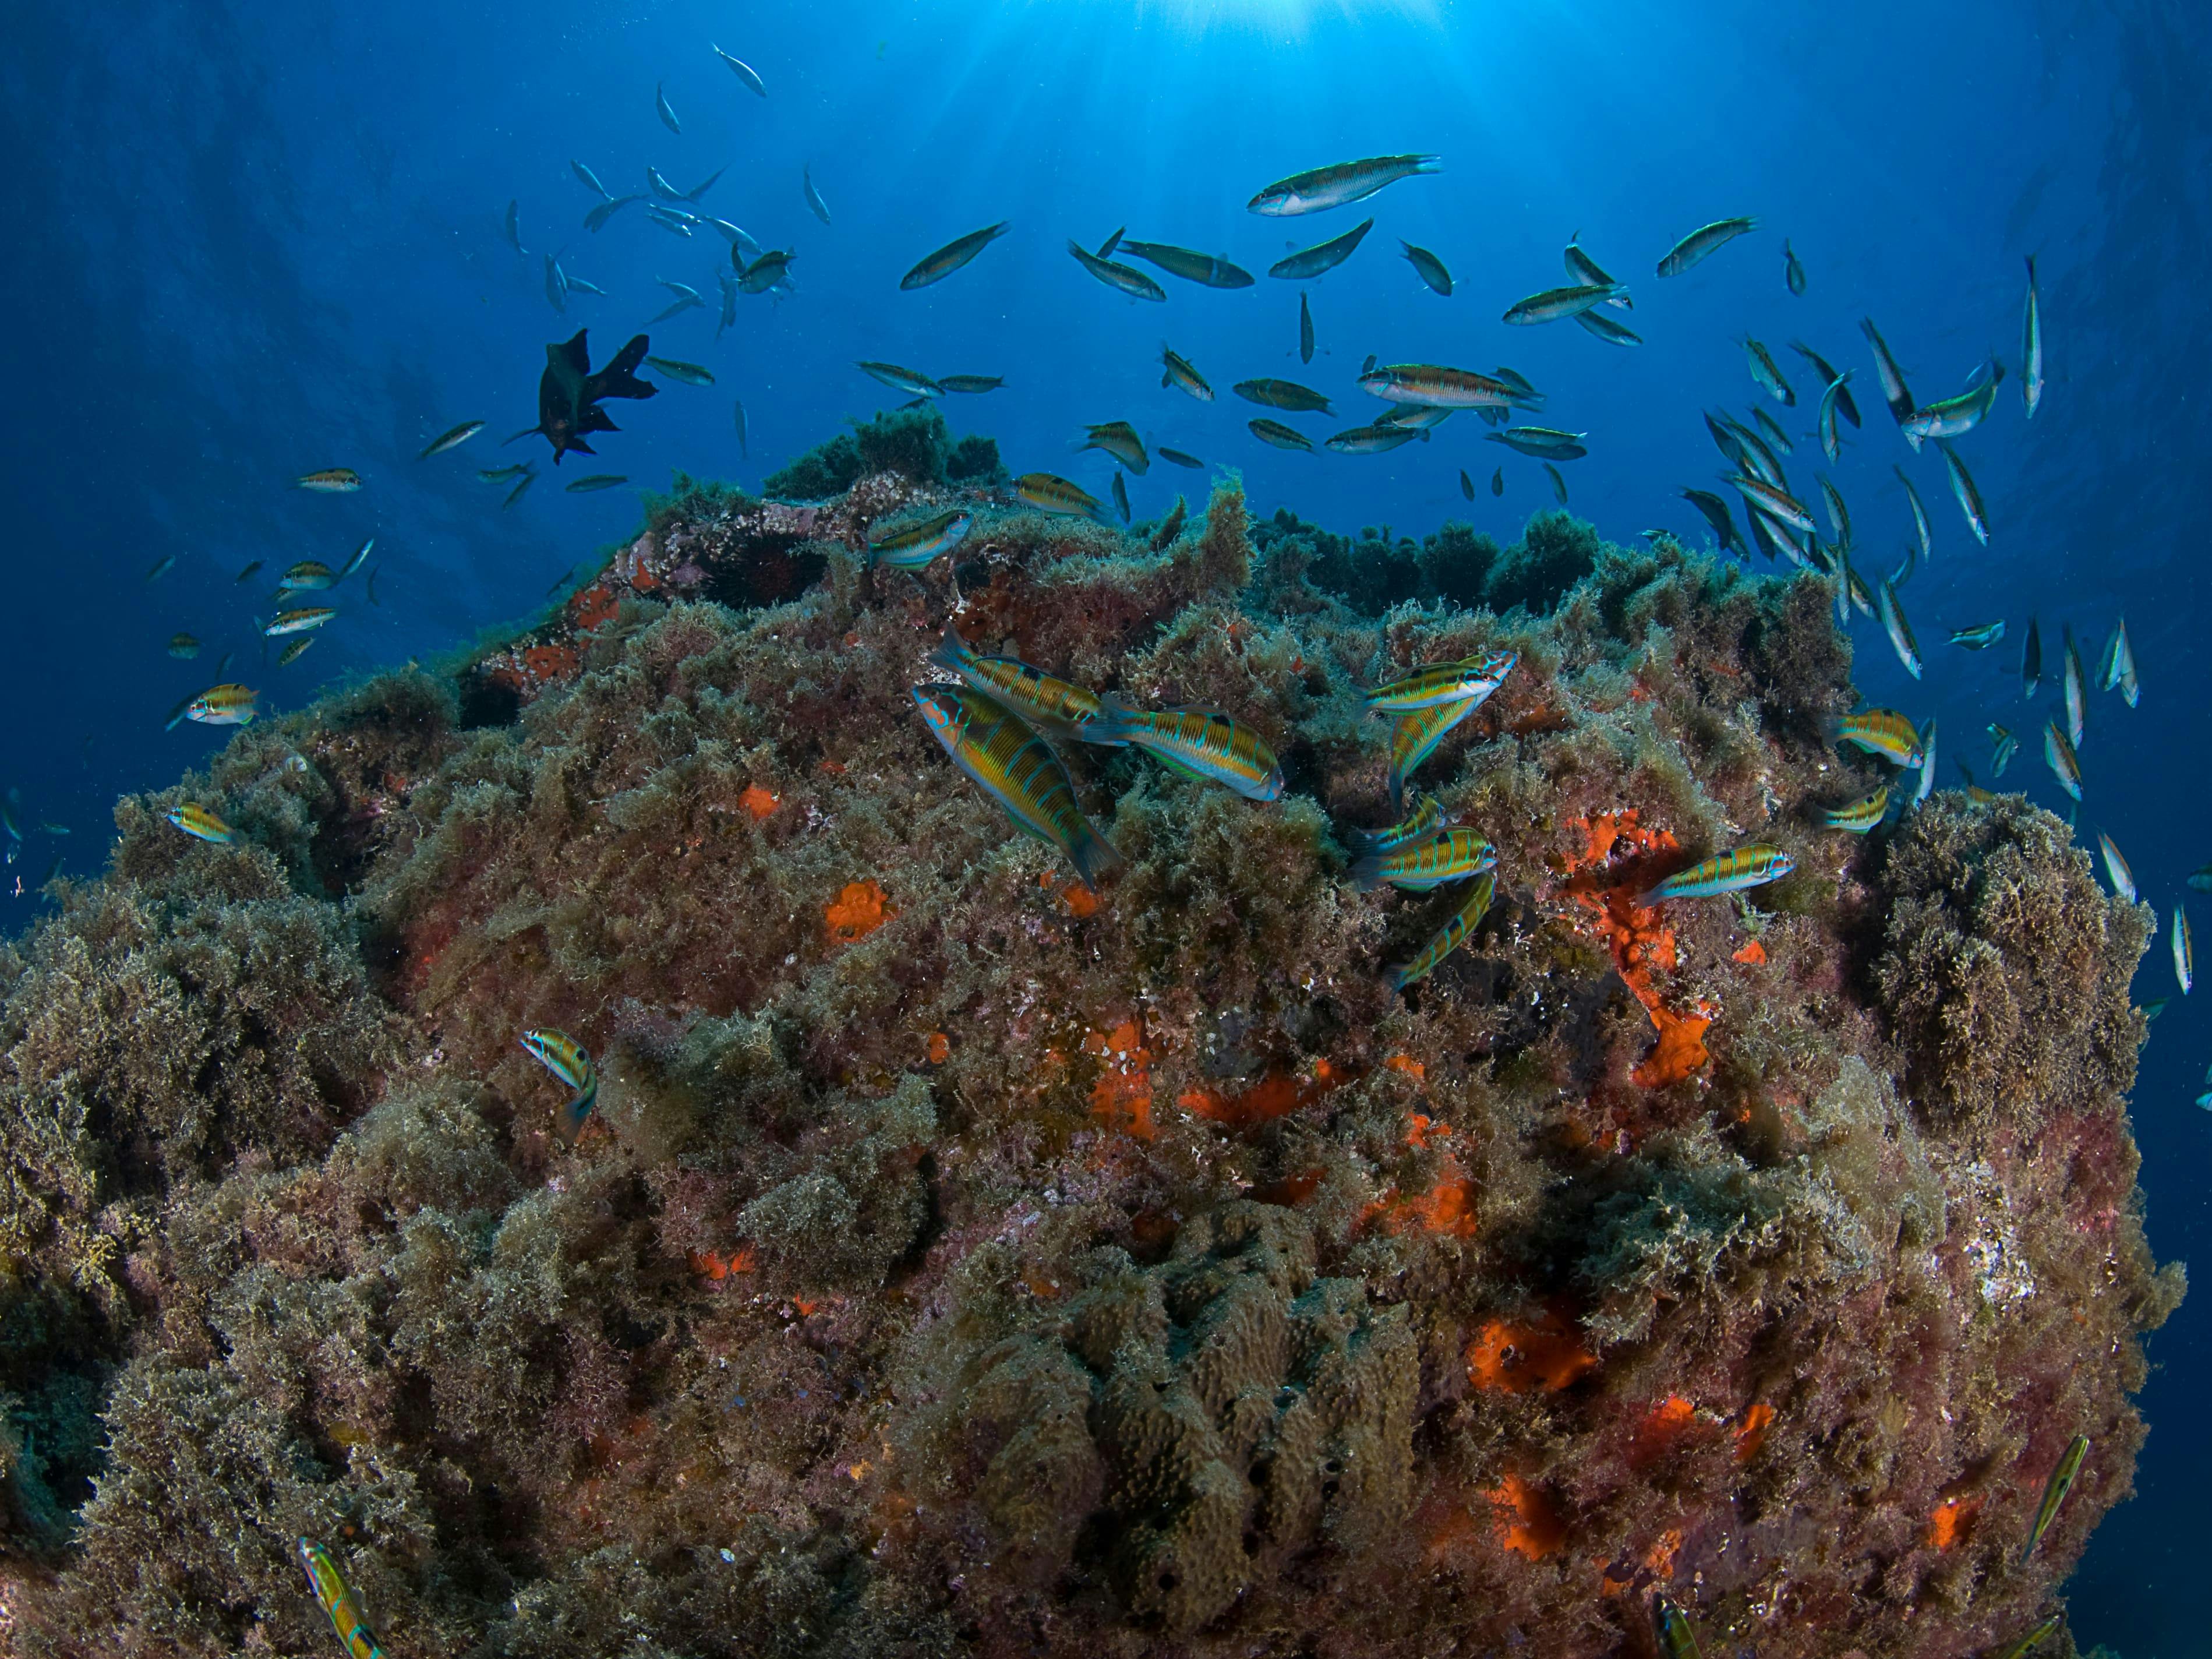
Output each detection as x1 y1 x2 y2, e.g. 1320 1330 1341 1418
0 444 2181 1659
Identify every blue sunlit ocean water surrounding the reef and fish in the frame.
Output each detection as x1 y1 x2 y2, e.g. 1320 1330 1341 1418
0 0 2212 1659
